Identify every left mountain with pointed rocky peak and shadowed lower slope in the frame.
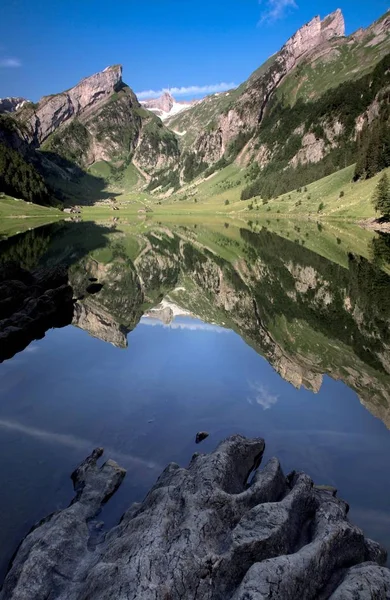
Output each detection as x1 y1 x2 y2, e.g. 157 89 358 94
0 65 179 201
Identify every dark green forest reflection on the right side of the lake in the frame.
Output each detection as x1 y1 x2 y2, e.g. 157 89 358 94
241 229 390 371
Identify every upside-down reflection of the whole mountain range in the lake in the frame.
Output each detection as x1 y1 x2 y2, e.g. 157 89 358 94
0 223 390 428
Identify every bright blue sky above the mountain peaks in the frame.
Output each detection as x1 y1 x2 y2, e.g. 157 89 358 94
0 0 388 101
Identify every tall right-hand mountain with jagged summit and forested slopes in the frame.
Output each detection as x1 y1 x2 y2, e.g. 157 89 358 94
160 10 390 198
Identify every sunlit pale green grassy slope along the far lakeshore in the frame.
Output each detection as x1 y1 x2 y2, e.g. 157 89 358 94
75 165 390 222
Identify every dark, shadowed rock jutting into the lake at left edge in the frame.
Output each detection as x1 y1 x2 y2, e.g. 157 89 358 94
0 263 73 362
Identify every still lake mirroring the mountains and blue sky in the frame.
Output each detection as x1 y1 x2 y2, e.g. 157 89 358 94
0 218 390 577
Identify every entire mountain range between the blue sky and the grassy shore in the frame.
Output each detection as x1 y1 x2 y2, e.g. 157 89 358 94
0 9 390 204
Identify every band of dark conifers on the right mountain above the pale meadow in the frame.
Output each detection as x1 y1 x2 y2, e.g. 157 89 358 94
241 55 390 200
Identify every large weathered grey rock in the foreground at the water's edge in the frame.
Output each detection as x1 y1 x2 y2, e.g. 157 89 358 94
0 435 390 600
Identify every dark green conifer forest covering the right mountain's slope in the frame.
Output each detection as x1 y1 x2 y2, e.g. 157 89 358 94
241 54 390 200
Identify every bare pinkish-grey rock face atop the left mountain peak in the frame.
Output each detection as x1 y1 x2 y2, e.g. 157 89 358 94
20 65 122 146
